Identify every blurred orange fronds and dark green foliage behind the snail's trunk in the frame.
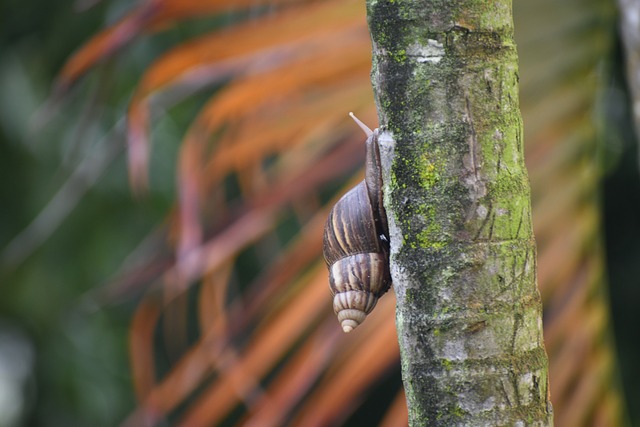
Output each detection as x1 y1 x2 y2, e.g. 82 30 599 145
0 0 640 427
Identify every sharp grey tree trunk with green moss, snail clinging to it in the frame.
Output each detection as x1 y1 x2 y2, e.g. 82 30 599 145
367 0 553 426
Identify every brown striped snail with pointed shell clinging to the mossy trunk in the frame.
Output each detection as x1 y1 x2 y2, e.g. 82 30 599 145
323 113 391 333
